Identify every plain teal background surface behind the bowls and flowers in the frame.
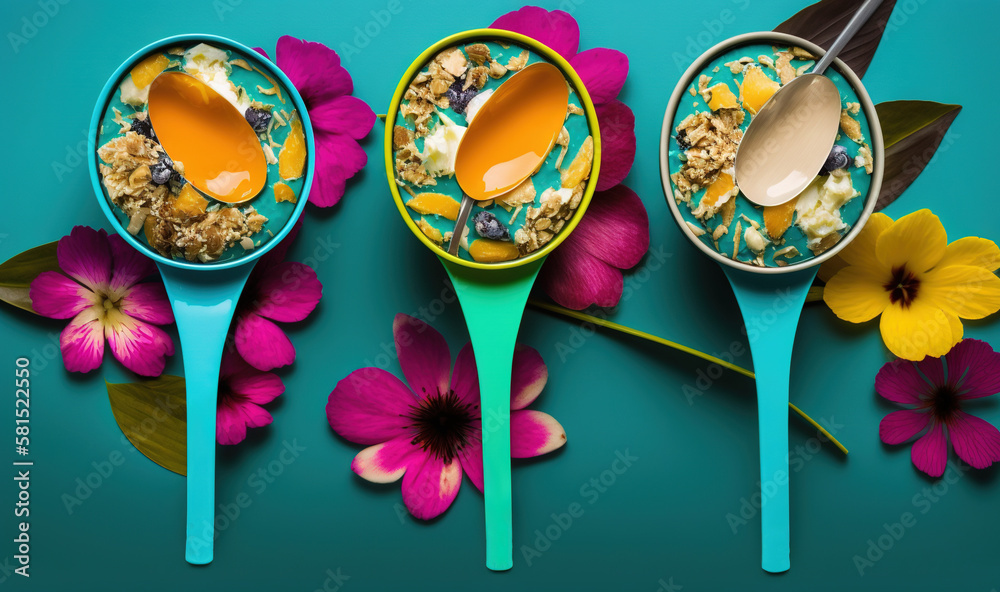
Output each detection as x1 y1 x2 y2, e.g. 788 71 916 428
0 0 1000 592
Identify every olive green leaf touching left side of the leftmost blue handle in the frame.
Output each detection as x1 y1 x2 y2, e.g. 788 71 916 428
105 375 187 475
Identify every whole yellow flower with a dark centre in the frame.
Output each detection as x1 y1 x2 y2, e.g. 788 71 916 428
820 210 1000 360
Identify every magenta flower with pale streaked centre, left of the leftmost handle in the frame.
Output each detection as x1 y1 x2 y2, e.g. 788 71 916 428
29 226 174 376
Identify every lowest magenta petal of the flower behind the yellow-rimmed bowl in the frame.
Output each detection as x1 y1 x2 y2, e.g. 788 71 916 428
538 232 625 310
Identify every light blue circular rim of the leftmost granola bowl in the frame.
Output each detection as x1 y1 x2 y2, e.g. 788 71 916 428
87 33 316 271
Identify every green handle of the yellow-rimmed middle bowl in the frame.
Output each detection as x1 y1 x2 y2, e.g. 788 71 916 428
441 257 545 571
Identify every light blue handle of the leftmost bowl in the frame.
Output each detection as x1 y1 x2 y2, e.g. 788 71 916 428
159 263 253 565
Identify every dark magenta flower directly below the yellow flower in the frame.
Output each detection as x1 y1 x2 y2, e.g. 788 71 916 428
875 339 1000 477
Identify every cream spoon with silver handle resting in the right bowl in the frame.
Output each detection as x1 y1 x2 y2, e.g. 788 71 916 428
736 0 882 206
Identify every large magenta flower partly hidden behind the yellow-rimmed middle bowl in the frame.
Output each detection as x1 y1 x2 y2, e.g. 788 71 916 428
491 6 649 310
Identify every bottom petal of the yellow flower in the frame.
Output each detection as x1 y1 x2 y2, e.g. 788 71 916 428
880 300 962 360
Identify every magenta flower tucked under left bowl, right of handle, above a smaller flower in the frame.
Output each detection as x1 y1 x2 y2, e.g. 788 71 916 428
233 223 323 371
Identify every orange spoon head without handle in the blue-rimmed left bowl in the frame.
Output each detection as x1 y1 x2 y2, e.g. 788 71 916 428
149 72 267 204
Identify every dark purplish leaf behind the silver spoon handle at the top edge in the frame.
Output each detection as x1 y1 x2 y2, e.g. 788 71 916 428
774 0 896 78
